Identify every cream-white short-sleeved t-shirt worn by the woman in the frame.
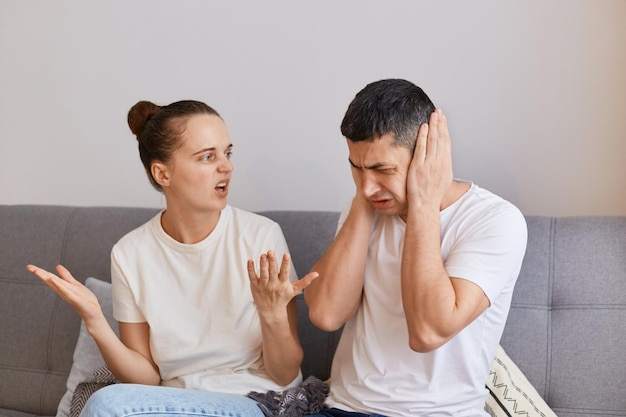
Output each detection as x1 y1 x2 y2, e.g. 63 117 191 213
111 206 302 394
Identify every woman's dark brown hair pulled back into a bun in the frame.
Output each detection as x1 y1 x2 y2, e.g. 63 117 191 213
128 100 221 191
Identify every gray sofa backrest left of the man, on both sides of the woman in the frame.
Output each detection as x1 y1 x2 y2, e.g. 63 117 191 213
0 205 339 415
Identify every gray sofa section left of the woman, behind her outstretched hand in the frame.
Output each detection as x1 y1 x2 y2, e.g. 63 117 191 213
0 206 158 415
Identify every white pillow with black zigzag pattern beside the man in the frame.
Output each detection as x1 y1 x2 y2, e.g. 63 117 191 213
485 346 557 417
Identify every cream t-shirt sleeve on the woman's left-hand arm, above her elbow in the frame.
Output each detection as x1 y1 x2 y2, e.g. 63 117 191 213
111 247 146 323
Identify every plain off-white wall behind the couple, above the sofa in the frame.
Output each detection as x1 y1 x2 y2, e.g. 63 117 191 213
0 0 626 215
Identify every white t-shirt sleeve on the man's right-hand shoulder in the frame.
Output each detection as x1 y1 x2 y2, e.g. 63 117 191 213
445 206 527 301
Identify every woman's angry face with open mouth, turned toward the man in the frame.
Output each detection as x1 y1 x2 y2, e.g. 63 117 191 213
157 114 233 212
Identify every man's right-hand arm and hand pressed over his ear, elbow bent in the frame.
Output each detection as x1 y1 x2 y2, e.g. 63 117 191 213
401 110 489 352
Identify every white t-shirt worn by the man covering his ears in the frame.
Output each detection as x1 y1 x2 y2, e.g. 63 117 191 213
327 184 527 417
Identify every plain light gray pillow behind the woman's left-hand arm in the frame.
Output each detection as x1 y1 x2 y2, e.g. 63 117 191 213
57 278 119 417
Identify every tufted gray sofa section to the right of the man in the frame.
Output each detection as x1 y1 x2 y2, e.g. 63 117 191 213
501 216 626 417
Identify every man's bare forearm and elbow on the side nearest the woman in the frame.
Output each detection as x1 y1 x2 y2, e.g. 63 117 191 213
304 190 374 331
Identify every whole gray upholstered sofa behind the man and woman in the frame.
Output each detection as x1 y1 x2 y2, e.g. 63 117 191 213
0 206 626 417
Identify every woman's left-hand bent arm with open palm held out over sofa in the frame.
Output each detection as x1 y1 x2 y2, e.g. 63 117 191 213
26 265 161 385
